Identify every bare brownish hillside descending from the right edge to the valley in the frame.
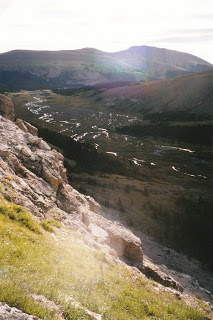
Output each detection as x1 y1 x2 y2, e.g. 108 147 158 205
96 71 213 116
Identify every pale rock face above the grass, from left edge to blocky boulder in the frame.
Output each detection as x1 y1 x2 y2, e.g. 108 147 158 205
0 117 143 266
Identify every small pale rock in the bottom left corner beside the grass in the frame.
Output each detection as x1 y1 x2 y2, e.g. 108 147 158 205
0 302 39 320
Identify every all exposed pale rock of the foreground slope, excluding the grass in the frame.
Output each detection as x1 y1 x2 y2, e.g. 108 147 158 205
0 95 212 320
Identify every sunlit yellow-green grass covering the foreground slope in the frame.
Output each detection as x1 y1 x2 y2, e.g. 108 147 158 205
0 196 210 320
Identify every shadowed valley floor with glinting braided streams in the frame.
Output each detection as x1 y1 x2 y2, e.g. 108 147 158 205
10 84 213 266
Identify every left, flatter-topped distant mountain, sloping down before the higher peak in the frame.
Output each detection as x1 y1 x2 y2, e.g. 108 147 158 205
0 48 150 89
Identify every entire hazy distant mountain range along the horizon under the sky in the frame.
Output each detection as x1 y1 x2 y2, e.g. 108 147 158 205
0 46 213 90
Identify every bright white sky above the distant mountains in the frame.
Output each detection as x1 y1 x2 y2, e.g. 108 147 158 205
0 0 213 63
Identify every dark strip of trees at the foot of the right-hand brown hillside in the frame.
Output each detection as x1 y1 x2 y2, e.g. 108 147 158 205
116 123 213 145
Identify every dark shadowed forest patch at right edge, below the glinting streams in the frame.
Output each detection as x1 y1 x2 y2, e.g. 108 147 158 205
150 195 213 270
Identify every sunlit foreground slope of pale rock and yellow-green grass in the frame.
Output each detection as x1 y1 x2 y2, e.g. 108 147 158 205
0 95 212 320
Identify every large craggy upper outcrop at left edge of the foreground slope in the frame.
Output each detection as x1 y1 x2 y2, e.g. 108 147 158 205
0 118 85 218
